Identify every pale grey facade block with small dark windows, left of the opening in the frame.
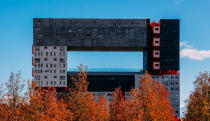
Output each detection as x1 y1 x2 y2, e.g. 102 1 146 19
32 46 67 87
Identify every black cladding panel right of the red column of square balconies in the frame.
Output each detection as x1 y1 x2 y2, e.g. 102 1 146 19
160 19 179 70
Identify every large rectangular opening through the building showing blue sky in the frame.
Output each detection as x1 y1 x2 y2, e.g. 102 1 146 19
67 51 143 72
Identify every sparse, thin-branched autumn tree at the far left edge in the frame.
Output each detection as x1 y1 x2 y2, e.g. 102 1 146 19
0 71 25 120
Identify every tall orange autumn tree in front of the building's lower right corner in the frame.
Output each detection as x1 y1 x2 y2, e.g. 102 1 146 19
139 72 175 121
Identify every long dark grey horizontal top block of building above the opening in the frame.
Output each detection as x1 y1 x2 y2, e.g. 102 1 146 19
33 18 150 51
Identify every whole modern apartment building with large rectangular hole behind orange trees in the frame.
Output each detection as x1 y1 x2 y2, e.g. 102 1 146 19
32 18 180 116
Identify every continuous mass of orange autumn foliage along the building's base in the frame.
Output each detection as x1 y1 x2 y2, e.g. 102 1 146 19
0 69 174 121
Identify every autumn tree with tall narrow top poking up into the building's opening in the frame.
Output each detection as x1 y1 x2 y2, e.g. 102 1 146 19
68 65 108 121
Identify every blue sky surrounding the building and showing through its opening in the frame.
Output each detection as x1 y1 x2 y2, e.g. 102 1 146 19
0 0 210 116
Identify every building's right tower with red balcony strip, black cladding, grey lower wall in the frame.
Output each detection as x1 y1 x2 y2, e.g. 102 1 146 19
145 19 180 116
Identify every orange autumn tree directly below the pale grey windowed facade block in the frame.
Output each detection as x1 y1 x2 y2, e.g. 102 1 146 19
20 81 72 121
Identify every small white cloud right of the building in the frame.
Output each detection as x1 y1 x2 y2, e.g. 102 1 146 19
180 48 210 60
